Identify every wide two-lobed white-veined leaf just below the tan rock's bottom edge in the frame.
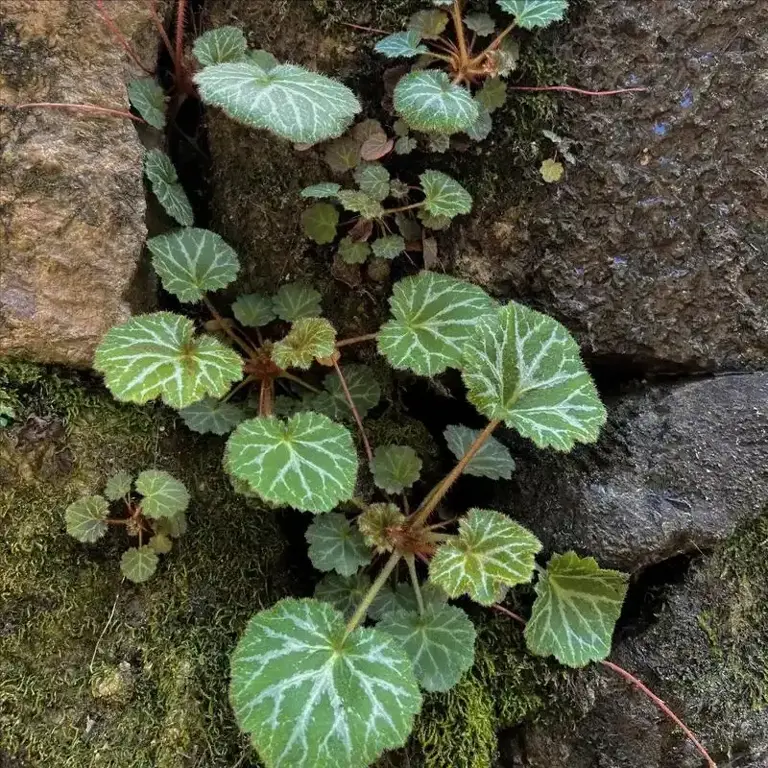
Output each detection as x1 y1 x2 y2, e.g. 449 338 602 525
93 312 243 408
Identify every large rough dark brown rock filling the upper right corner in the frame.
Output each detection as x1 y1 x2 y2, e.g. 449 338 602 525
450 0 768 370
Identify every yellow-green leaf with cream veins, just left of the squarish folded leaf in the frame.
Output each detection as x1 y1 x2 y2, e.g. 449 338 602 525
429 509 541 605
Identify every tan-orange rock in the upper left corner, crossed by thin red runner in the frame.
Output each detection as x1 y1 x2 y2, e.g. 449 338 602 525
0 0 156 366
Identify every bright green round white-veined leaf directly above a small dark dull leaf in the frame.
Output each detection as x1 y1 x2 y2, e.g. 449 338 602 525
225 412 357 512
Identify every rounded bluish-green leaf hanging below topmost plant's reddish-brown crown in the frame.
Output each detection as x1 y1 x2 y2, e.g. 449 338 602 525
394 69 478 134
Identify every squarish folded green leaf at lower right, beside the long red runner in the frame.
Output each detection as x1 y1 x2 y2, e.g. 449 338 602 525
525 552 627 667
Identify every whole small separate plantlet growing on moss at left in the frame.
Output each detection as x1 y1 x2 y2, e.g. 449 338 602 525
65 469 189 584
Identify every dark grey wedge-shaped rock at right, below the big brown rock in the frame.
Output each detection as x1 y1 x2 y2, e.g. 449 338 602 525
491 373 768 571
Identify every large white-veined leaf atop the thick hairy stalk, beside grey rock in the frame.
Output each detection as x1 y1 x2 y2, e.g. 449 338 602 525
462 302 606 451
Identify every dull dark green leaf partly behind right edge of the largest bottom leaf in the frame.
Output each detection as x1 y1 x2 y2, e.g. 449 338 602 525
377 605 477 691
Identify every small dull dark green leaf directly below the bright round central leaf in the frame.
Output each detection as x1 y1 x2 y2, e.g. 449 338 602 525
306 512 372 576
